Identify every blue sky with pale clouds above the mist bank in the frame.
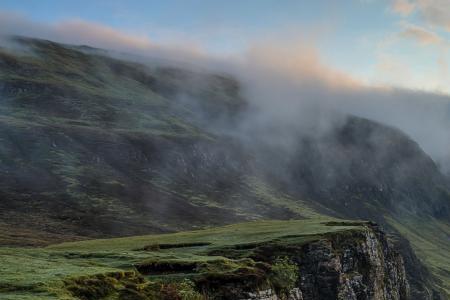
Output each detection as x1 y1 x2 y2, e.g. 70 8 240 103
0 0 450 94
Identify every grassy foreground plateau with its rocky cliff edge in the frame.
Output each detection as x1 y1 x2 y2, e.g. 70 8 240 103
0 220 409 300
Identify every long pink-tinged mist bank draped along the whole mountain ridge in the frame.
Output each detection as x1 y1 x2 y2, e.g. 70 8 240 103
0 13 450 173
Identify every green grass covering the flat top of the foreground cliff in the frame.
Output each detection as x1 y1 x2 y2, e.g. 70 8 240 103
0 220 362 300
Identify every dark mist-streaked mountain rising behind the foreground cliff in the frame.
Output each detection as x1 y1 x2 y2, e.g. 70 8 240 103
0 38 450 299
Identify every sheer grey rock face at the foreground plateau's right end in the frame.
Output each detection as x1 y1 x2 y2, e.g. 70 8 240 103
299 227 409 300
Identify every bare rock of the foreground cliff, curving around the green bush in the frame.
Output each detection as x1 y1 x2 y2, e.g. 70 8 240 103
224 225 411 300
